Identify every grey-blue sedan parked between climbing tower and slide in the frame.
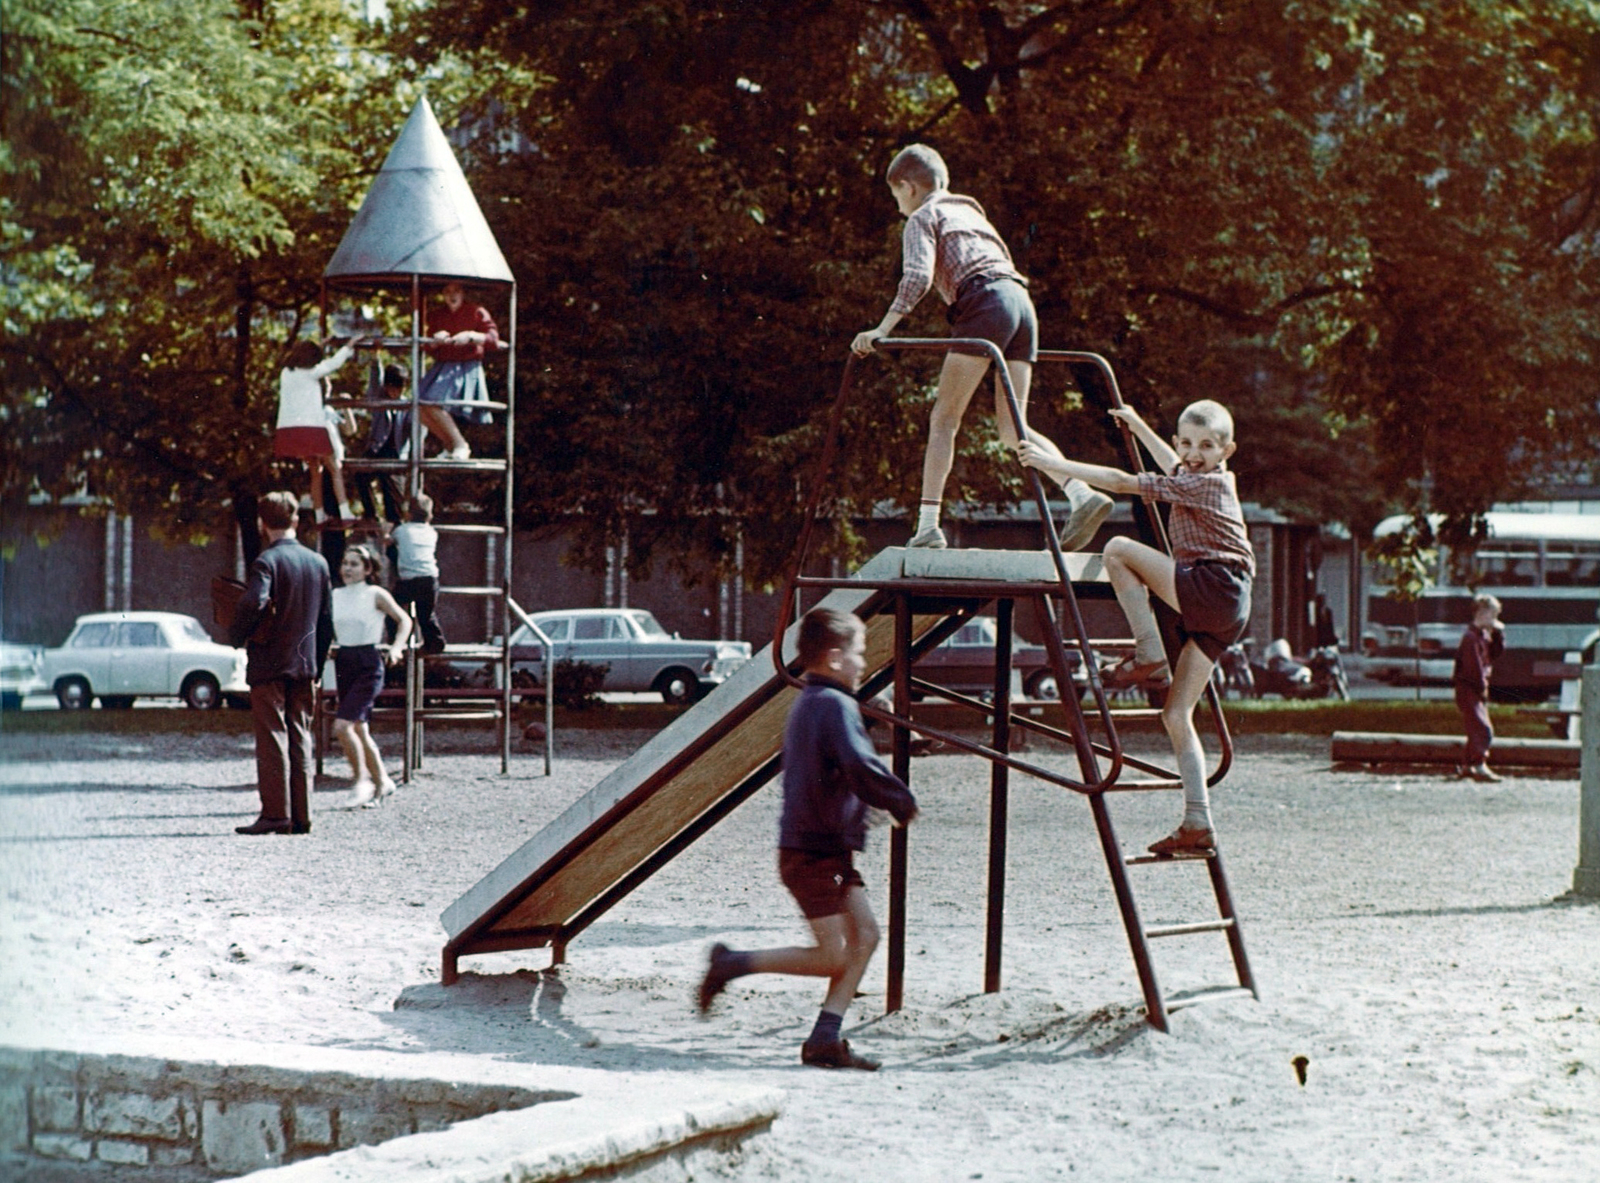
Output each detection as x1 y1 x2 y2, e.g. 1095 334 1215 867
510 608 750 703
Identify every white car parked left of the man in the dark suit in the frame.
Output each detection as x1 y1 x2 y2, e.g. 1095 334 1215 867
38 612 250 711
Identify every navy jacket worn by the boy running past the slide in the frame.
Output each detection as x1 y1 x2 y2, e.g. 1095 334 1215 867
778 674 917 855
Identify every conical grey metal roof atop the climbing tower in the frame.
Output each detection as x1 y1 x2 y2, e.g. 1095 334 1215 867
323 98 514 283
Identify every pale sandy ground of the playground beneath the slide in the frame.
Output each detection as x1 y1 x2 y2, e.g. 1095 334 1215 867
0 717 1600 1183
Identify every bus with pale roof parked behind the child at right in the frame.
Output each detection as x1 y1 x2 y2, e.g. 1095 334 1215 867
1362 512 1600 701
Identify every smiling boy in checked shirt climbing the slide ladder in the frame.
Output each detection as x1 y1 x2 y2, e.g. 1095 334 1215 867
1018 399 1256 856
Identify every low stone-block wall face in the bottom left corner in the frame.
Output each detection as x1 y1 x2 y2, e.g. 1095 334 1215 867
0 1047 576 1177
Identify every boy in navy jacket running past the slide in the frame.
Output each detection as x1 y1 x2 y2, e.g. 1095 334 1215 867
698 608 917 1073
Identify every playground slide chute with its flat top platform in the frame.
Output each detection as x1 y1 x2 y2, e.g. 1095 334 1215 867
440 547 1104 984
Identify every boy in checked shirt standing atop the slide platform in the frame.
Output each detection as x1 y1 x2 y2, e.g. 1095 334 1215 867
850 144 1112 551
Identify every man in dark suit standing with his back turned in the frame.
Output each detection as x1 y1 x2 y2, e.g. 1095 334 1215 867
229 493 333 834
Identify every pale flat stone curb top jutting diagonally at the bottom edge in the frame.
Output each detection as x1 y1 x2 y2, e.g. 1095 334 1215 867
242 1085 782 1183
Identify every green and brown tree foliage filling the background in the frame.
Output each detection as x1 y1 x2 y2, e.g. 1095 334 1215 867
5 0 1600 581
